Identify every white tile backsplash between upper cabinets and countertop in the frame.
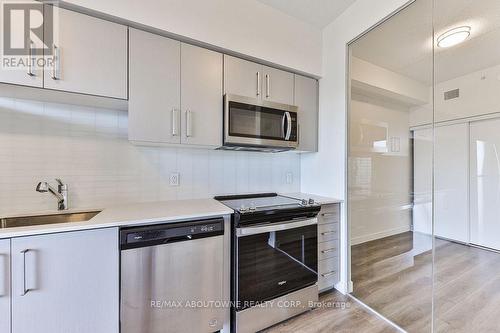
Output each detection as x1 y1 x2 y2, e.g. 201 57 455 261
0 98 300 216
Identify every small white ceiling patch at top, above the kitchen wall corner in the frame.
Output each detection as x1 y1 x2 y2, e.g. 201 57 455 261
257 0 356 28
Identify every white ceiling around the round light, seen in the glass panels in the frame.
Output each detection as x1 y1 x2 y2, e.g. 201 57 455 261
352 0 500 85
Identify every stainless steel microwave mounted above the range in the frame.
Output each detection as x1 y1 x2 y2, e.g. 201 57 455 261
222 94 298 152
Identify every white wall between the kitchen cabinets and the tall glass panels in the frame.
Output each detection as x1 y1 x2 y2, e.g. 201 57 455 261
301 0 414 292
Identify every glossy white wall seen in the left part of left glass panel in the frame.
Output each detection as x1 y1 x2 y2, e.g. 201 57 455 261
349 94 412 245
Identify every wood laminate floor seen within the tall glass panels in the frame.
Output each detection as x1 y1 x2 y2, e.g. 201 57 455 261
352 232 500 333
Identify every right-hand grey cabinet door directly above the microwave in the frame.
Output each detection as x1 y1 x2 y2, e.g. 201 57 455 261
262 66 294 105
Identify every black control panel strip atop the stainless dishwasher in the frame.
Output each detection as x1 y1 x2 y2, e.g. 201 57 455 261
120 218 224 250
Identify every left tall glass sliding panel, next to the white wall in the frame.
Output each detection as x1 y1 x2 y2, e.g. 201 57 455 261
347 0 434 332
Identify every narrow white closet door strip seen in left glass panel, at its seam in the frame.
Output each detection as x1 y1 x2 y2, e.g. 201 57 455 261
413 129 432 235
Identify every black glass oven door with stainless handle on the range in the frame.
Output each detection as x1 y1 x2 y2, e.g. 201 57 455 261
235 218 318 311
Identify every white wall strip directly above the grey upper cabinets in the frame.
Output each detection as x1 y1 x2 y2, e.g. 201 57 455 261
61 0 321 75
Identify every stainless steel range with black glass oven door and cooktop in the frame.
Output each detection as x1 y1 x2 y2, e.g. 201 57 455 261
215 193 321 333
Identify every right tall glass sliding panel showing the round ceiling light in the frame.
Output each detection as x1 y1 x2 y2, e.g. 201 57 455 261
433 0 500 332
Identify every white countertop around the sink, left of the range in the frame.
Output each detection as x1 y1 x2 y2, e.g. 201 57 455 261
0 199 233 239
